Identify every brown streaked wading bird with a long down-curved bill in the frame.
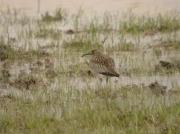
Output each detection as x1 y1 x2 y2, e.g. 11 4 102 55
82 49 119 82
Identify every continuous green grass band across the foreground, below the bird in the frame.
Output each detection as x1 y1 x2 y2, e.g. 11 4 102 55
0 88 180 134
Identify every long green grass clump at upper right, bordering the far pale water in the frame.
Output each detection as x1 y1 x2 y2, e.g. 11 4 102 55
119 14 180 34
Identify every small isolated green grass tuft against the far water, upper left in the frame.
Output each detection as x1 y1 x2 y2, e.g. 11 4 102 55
41 8 65 22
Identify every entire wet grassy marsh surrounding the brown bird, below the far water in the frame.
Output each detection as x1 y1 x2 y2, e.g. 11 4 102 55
0 9 180 134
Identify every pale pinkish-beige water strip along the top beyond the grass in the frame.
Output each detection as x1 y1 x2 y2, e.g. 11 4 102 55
0 0 180 14
